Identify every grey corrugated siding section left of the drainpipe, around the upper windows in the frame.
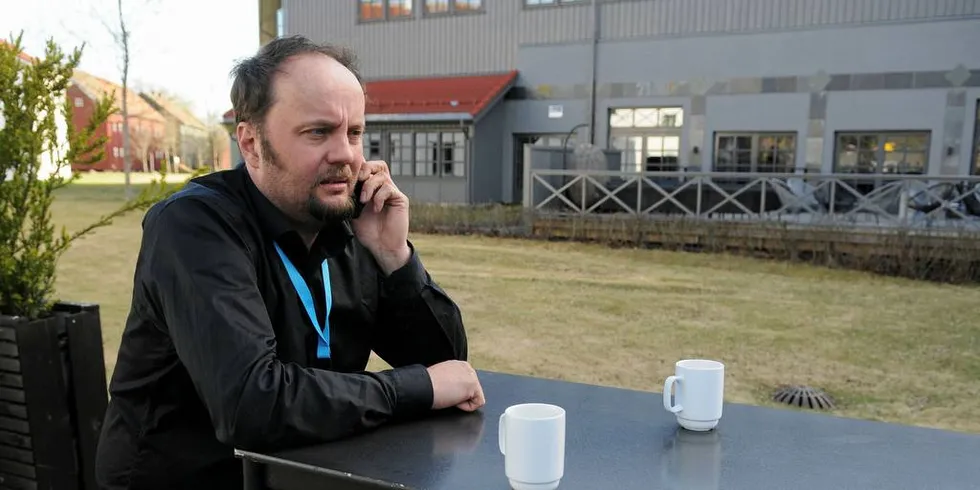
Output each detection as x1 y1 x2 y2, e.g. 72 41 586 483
285 0 592 78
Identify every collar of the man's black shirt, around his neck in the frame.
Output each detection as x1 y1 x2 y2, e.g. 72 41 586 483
236 162 354 254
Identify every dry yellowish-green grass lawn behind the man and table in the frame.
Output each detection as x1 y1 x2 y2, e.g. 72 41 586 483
54 178 980 432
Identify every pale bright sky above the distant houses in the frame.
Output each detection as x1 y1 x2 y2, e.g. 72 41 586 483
0 0 259 120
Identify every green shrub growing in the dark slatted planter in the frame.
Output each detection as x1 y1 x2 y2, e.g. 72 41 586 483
0 37 186 319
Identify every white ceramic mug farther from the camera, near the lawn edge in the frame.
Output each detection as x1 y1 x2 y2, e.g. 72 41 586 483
663 359 725 431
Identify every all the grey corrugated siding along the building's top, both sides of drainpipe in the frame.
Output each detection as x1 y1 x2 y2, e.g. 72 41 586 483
283 0 980 78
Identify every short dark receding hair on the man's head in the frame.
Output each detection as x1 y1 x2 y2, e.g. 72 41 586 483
231 36 364 124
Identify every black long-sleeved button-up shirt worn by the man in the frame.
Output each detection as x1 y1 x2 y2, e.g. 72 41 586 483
97 165 467 489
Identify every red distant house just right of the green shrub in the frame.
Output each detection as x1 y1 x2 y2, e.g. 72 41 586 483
68 70 167 172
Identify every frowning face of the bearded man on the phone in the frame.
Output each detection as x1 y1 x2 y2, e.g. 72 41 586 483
250 54 364 224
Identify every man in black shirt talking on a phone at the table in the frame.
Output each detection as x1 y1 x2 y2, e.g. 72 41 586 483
96 37 484 490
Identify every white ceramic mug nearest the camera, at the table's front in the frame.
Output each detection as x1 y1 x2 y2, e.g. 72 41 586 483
497 403 565 490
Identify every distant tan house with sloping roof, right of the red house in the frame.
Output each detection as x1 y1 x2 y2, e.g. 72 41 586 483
140 92 213 170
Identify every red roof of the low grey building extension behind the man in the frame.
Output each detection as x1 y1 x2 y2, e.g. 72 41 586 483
366 71 517 117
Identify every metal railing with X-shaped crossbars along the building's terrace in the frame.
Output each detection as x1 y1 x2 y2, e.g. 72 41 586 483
524 169 980 232
